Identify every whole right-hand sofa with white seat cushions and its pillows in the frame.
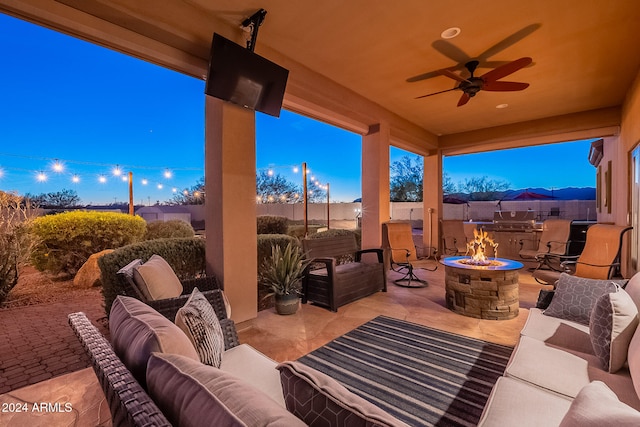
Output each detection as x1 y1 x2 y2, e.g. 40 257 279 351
479 273 640 427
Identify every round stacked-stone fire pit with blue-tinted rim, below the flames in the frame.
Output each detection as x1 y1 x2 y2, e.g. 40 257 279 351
440 256 523 320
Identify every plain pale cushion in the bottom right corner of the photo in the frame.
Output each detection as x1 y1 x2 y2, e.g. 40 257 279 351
560 381 640 427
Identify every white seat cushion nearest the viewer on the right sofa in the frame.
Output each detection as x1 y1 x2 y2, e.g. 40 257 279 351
478 377 571 427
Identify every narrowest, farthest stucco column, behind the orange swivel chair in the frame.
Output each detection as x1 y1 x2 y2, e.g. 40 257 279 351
422 150 442 256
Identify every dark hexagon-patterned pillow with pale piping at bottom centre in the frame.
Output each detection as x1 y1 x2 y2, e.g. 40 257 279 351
277 362 406 427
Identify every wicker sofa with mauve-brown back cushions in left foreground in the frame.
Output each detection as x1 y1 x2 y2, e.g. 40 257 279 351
69 291 406 427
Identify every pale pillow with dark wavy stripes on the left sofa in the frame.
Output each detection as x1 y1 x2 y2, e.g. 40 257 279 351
175 288 224 368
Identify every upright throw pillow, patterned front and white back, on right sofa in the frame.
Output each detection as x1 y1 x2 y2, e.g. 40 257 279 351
589 287 638 373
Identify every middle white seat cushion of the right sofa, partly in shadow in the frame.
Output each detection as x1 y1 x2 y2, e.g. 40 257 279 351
505 337 640 409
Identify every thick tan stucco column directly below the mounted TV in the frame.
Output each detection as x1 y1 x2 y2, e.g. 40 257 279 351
205 96 258 322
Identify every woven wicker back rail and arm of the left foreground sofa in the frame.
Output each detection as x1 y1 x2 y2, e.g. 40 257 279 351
69 290 240 427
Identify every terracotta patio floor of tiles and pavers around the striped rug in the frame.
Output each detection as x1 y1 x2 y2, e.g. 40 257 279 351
0 266 540 426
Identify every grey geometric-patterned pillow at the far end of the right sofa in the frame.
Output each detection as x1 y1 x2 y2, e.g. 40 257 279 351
544 273 626 326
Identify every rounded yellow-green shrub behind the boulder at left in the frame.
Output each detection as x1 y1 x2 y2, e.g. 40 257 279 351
30 211 147 275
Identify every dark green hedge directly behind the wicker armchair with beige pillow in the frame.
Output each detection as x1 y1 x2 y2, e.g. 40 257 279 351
98 237 205 314
